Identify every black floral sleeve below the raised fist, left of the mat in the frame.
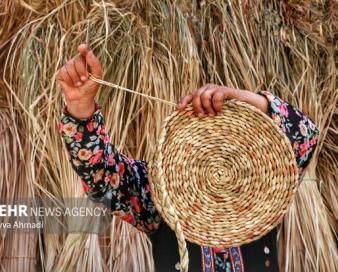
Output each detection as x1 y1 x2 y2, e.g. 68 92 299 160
58 103 161 233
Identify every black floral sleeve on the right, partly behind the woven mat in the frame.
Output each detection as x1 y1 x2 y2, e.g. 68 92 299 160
259 91 319 178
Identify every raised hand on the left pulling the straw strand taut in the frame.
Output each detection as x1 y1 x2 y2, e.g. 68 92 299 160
57 44 102 119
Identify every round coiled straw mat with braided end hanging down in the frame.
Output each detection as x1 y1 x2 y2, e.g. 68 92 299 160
150 100 298 271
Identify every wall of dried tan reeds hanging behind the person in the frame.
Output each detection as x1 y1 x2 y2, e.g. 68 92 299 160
0 0 338 272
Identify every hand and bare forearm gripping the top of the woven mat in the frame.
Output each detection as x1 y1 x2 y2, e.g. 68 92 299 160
178 84 268 117
